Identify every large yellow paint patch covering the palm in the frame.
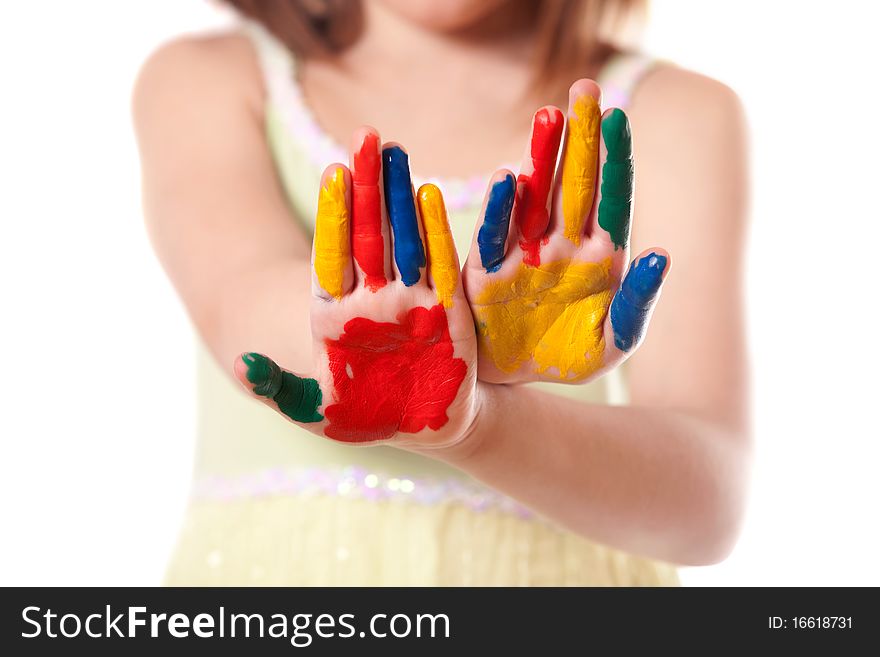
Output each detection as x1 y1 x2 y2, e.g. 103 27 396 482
474 258 611 381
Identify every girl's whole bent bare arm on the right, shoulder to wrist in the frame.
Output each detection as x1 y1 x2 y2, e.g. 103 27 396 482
435 69 750 564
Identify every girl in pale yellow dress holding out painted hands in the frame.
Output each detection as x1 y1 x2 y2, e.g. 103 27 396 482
134 0 751 585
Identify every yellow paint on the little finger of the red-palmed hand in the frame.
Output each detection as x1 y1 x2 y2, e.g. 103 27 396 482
418 183 458 308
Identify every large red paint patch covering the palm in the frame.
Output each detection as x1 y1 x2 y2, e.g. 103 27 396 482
324 304 467 443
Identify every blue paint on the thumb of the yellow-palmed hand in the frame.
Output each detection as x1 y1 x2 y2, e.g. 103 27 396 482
611 253 667 351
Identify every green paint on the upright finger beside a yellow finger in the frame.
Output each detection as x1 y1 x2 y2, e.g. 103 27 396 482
599 109 633 250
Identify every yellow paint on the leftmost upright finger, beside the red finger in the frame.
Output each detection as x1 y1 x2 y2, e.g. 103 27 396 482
315 167 351 299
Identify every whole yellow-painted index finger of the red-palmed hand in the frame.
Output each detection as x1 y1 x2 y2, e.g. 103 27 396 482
312 164 354 299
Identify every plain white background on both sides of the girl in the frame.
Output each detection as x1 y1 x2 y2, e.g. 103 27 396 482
0 0 880 585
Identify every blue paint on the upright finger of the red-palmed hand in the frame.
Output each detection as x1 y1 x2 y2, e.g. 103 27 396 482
382 146 425 286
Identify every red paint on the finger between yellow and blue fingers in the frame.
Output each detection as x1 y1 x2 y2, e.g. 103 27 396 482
351 133 386 292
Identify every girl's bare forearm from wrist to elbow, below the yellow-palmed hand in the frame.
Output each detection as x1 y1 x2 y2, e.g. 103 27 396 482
433 386 749 565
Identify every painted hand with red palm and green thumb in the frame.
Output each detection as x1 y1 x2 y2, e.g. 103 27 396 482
235 128 479 448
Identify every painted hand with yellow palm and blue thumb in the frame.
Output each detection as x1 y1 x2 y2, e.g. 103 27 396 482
463 80 669 383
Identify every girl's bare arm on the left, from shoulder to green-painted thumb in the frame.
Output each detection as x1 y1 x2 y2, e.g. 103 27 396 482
134 36 312 368
